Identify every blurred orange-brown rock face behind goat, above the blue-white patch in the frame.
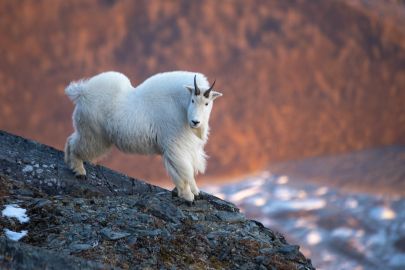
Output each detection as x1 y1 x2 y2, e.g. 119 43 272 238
0 0 405 185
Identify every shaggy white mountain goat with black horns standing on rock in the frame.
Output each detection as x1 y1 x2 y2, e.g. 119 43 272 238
65 71 222 201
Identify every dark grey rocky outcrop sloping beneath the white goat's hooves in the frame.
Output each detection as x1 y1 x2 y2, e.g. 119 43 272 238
0 132 313 269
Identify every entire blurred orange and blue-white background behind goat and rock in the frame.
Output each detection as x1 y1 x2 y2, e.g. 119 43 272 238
0 0 405 269
